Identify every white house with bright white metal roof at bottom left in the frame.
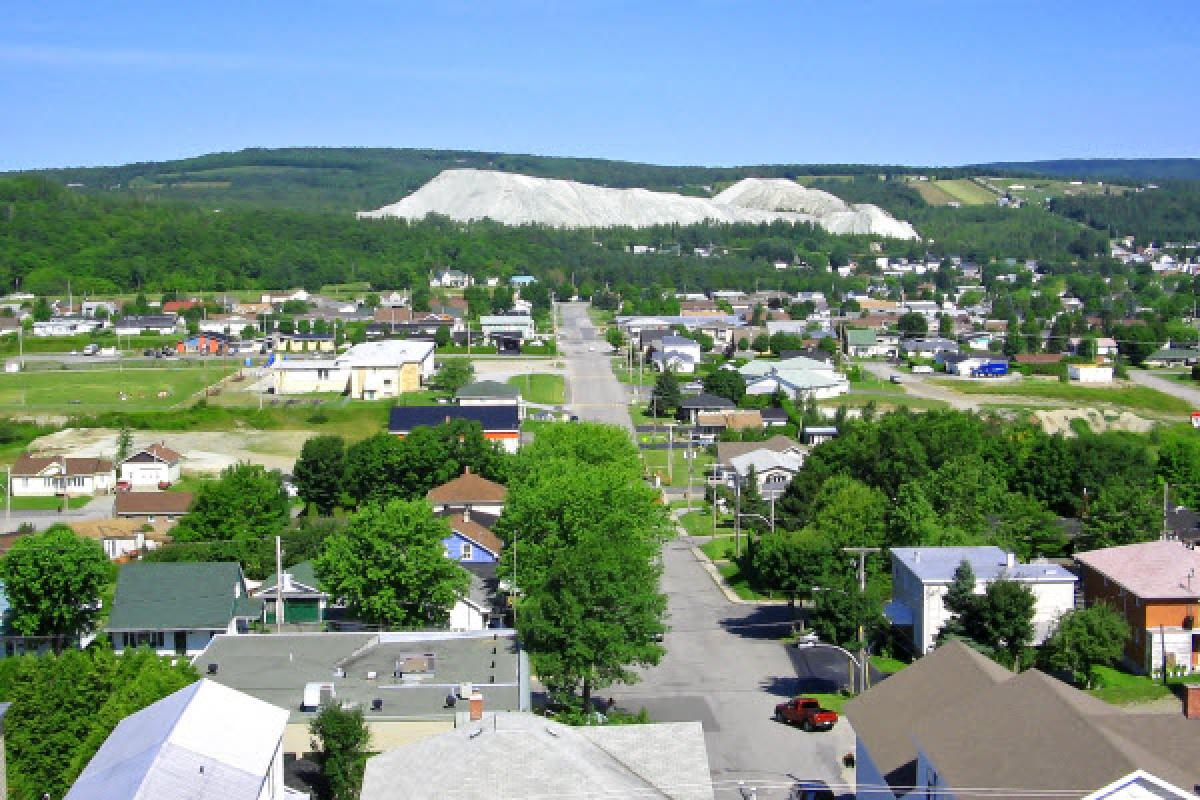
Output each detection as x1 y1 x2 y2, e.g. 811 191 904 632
66 679 300 800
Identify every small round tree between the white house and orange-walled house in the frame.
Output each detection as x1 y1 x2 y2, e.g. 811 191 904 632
1042 603 1129 688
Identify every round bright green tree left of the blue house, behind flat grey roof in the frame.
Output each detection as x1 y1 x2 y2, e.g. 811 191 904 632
314 500 470 627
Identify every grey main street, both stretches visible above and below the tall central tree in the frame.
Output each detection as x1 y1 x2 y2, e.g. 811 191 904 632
559 303 854 800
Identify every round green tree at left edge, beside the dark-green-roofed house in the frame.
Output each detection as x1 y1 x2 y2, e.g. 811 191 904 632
0 525 113 649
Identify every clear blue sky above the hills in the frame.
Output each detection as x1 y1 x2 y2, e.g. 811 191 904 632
0 0 1200 169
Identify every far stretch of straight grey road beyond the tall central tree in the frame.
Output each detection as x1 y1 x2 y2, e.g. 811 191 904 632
558 302 634 435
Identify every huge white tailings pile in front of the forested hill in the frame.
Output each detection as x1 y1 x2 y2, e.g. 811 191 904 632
359 169 918 239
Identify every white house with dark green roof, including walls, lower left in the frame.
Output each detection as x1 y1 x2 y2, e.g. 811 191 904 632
104 561 263 656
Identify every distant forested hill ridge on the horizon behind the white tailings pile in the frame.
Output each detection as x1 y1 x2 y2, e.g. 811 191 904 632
21 148 1200 213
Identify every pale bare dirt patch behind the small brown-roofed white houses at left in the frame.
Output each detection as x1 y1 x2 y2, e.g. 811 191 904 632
29 428 312 475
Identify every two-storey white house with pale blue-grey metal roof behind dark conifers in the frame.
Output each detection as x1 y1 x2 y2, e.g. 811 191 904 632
886 547 1076 655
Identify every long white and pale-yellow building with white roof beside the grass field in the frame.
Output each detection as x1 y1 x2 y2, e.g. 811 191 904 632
271 339 434 399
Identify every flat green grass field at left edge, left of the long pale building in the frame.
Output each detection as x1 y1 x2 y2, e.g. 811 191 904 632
0 366 234 414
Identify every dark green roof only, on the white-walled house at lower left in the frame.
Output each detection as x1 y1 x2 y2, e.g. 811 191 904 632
107 563 262 631
